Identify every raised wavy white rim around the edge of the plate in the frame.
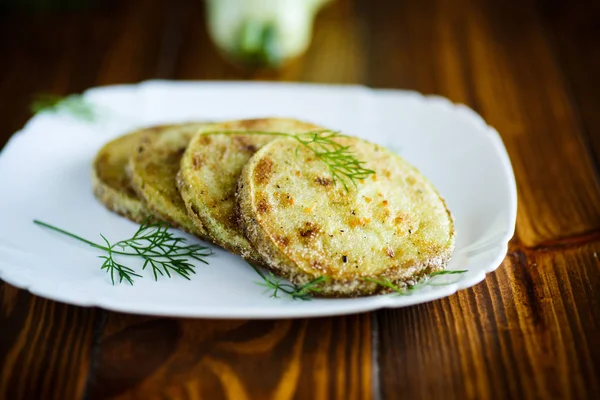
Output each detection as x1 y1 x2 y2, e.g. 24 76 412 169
0 79 518 319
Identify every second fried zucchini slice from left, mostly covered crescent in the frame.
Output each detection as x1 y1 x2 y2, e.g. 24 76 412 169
128 123 206 238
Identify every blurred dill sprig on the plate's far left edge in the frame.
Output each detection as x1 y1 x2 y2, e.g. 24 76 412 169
30 93 97 122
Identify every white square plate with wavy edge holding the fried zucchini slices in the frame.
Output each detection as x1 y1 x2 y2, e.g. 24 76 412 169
0 81 517 318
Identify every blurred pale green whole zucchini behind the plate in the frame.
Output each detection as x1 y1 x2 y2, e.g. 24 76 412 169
206 0 331 68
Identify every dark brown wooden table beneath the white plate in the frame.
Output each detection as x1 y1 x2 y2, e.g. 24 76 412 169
0 0 600 400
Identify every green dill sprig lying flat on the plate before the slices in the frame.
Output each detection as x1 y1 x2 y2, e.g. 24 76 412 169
33 220 212 285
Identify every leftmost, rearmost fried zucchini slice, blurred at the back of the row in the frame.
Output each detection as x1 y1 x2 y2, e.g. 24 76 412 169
92 128 156 223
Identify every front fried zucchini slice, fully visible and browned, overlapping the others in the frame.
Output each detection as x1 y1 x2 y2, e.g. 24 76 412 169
237 137 454 297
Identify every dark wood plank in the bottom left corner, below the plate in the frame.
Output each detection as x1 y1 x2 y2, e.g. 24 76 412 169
0 283 99 400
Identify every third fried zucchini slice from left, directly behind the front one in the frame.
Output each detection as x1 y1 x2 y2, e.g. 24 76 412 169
178 118 322 264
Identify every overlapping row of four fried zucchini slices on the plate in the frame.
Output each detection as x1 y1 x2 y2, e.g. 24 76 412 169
93 118 454 297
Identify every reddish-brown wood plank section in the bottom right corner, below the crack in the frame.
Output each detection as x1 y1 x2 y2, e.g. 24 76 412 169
378 243 600 399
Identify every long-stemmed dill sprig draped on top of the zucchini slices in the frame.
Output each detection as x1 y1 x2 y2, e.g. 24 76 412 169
205 129 375 191
